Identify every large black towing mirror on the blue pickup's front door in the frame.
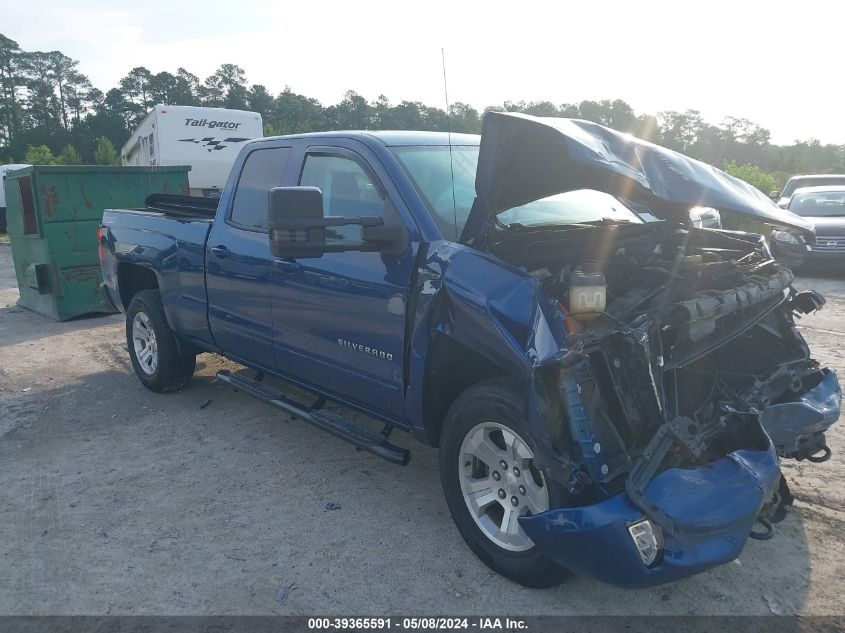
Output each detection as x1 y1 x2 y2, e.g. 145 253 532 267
267 187 410 258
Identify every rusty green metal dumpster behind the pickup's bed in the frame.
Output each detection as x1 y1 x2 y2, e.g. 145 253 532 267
6 165 190 321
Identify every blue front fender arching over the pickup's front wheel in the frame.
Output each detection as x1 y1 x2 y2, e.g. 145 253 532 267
406 241 571 483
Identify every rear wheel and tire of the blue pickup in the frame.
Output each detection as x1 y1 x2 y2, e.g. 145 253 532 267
126 290 197 393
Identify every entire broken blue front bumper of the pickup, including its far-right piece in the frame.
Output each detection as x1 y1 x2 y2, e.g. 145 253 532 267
519 369 841 587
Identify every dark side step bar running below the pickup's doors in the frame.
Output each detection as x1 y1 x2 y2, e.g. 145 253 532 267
211 369 411 466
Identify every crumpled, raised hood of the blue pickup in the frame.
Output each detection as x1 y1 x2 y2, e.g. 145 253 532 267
461 112 813 243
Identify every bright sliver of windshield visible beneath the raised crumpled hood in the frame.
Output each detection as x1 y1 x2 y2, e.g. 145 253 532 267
498 189 643 226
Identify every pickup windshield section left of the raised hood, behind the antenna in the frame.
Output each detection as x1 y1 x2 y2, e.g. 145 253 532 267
390 145 478 240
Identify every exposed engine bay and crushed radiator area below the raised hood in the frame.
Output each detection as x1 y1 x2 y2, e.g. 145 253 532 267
491 222 838 523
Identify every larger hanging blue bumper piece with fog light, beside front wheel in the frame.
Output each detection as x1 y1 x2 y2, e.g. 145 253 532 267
519 445 781 587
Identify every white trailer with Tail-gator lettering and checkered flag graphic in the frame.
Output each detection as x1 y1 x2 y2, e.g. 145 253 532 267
120 104 264 197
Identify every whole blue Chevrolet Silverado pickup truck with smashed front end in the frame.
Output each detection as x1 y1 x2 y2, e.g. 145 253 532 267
99 113 841 587
